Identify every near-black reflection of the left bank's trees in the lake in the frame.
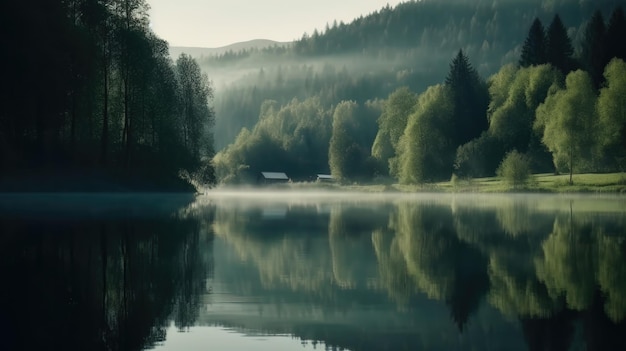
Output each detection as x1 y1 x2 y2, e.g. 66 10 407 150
0 195 212 350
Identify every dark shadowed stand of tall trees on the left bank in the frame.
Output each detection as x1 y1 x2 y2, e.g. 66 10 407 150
0 0 214 191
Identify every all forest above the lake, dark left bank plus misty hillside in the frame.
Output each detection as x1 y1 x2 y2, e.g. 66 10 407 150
0 0 626 191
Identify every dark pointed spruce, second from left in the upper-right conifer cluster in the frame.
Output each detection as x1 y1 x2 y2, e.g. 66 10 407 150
546 15 574 75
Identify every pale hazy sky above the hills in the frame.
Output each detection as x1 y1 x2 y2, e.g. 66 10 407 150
147 0 403 47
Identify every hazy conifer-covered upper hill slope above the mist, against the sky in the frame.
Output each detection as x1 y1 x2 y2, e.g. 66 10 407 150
293 0 617 59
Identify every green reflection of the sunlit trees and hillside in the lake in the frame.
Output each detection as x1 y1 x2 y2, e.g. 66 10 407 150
201 196 626 350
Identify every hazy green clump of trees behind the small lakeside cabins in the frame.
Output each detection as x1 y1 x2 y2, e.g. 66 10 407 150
213 98 331 183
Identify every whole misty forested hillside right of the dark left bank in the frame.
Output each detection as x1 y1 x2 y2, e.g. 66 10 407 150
208 0 626 184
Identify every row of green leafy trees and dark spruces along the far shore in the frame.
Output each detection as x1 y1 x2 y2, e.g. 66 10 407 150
215 7 626 184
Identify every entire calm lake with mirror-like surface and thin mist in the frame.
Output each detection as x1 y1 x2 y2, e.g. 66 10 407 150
0 191 626 351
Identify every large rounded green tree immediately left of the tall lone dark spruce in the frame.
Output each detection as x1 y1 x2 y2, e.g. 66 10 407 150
391 85 454 184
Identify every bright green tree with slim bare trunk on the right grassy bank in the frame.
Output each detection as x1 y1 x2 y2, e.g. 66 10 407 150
535 70 598 184
